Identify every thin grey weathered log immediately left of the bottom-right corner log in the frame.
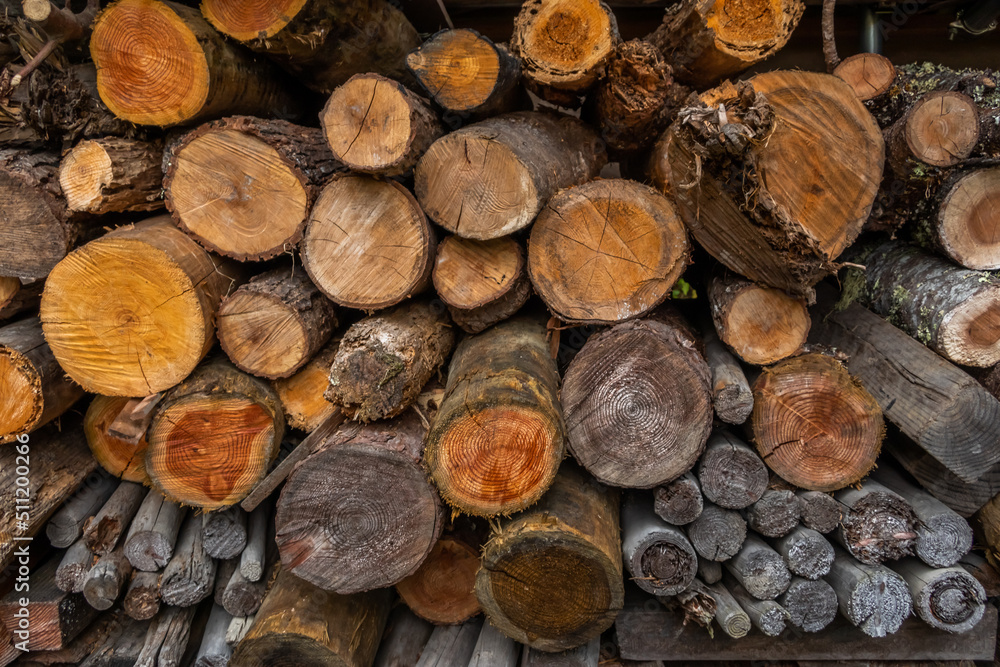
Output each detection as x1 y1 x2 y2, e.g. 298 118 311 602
826 548 913 637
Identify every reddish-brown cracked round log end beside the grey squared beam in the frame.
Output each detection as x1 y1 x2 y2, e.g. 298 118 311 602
751 352 885 491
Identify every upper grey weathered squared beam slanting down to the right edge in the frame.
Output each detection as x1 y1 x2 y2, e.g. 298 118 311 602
812 304 1000 481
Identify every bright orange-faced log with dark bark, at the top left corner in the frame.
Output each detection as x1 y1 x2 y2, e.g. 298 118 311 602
90 0 298 127
